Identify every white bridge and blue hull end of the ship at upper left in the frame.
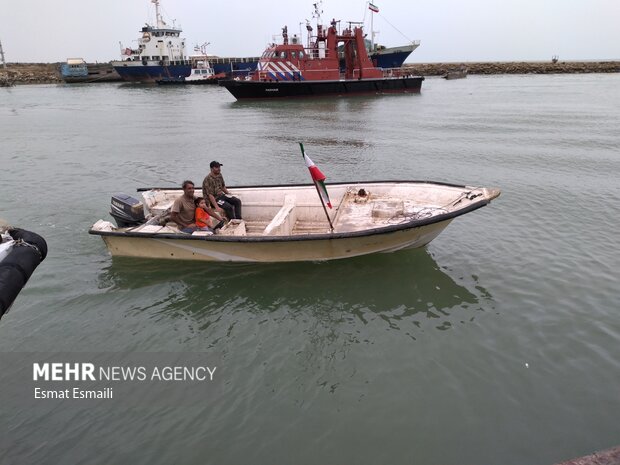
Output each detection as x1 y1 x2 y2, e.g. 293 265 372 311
112 0 192 82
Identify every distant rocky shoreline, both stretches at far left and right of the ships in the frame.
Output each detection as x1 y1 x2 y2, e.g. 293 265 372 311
0 60 620 86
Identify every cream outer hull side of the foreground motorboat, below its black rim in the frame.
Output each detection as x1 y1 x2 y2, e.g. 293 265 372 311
94 219 452 263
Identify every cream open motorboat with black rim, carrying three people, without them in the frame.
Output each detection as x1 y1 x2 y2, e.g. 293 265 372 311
89 181 500 262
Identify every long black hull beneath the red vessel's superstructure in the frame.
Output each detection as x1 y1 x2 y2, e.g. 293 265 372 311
219 77 424 100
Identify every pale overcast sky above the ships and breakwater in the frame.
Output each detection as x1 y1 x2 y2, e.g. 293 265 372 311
0 0 620 63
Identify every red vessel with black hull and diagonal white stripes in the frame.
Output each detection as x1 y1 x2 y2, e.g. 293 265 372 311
219 4 424 100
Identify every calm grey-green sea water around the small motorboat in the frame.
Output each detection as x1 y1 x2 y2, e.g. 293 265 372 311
0 75 620 465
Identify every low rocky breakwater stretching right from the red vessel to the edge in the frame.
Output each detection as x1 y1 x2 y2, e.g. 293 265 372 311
403 61 620 76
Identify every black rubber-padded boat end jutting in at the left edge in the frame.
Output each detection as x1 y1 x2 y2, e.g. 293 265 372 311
0 225 47 317
